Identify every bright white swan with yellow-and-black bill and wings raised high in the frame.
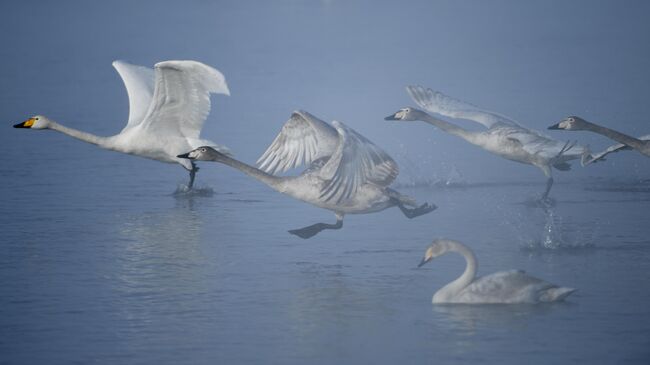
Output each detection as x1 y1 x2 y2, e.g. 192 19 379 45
14 61 230 190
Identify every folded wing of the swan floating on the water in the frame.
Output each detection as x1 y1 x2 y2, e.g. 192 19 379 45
461 270 557 303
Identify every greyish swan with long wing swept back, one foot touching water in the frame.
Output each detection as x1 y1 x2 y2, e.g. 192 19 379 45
384 86 590 200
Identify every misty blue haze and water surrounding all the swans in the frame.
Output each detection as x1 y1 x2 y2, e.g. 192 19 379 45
0 0 650 364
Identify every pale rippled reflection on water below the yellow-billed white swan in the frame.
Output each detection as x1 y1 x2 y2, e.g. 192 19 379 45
112 197 206 328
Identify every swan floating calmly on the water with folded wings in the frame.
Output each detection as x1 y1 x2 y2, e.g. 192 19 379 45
418 239 576 304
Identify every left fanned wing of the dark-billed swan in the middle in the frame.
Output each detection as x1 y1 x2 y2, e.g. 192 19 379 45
257 110 339 174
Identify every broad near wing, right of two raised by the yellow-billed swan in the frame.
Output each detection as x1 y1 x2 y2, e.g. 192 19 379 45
142 61 230 138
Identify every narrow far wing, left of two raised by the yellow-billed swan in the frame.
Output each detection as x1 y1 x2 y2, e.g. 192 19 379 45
113 60 154 129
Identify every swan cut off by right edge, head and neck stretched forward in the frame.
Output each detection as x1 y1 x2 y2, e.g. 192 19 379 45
548 116 650 163
